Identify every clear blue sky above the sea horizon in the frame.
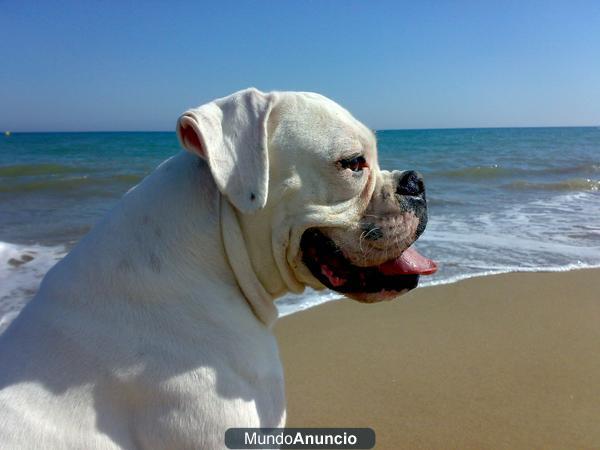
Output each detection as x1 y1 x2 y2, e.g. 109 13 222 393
0 0 600 131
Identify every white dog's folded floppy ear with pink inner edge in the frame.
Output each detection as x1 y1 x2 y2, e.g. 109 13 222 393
177 88 272 213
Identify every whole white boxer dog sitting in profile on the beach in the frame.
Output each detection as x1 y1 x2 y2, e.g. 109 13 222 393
0 89 435 449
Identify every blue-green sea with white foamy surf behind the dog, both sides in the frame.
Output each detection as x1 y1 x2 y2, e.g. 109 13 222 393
0 127 600 332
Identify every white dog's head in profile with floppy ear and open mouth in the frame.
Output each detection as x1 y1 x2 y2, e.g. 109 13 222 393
177 89 436 302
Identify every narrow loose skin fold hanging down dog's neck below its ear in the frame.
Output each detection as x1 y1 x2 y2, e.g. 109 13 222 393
220 196 278 327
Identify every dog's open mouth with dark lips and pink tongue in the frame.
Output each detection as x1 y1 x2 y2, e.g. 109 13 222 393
300 228 437 302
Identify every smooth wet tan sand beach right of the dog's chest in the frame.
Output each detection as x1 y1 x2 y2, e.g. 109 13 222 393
275 270 600 449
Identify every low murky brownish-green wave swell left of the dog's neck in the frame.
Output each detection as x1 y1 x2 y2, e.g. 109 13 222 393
0 174 143 193
